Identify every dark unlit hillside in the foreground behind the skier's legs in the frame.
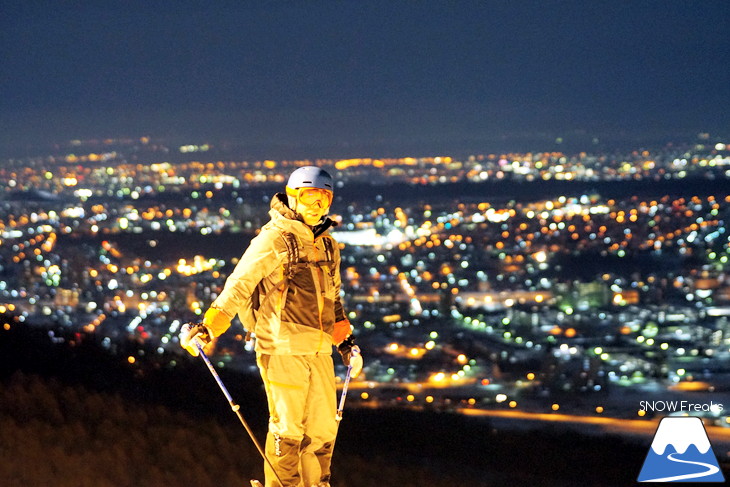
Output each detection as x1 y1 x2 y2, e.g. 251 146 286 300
0 318 700 487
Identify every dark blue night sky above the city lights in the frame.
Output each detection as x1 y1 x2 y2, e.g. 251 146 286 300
0 0 730 155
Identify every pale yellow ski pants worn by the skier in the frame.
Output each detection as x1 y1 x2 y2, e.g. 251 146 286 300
256 354 337 487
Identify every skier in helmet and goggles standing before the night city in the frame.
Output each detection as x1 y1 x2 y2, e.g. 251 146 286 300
180 166 362 487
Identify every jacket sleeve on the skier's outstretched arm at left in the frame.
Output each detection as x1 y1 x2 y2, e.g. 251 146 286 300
211 230 286 336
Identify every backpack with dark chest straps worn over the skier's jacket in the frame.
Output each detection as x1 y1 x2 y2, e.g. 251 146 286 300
238 232 334 341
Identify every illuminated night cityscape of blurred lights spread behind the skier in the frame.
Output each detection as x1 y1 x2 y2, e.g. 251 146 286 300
0 137 730 454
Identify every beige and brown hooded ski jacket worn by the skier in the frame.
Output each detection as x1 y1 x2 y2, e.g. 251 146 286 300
211 193 350 355
